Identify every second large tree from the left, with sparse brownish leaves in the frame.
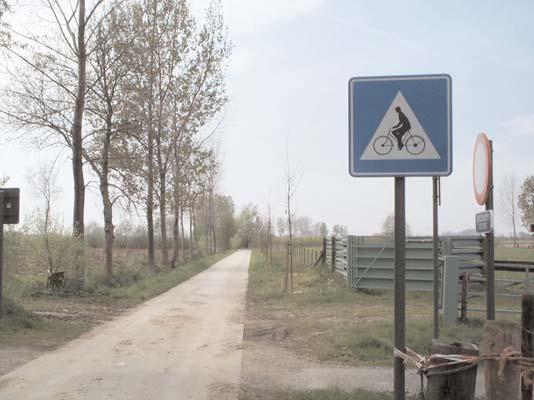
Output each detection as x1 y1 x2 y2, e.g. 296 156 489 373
84 3 137 278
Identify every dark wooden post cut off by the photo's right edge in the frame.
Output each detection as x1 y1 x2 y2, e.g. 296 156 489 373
521 294 534 400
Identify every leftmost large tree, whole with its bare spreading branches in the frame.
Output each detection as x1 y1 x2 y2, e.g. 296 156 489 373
1 0 109 235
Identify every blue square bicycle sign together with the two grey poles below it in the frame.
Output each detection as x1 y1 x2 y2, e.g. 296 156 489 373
349 75 452 400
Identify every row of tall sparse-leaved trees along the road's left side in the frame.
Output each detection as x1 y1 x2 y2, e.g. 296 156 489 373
0 0 233 277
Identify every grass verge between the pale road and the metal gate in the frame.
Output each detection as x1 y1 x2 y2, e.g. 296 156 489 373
248 252 483 366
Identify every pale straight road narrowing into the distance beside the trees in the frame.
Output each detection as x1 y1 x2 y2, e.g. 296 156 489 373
0 250 250 400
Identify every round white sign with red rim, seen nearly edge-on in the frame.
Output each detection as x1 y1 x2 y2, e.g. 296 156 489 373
473 133 491 205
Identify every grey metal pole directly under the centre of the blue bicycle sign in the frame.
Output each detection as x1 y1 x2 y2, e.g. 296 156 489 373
393 177 406 400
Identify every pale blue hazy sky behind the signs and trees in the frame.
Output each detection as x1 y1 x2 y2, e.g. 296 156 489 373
0 0 534 235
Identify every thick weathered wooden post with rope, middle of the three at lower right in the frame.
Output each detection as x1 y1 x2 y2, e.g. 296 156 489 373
481 321 521 400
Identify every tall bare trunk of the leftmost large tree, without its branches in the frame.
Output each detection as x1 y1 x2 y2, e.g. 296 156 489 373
72 0 87 237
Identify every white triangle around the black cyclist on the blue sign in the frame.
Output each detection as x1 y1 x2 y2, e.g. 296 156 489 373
360 91 441 161
